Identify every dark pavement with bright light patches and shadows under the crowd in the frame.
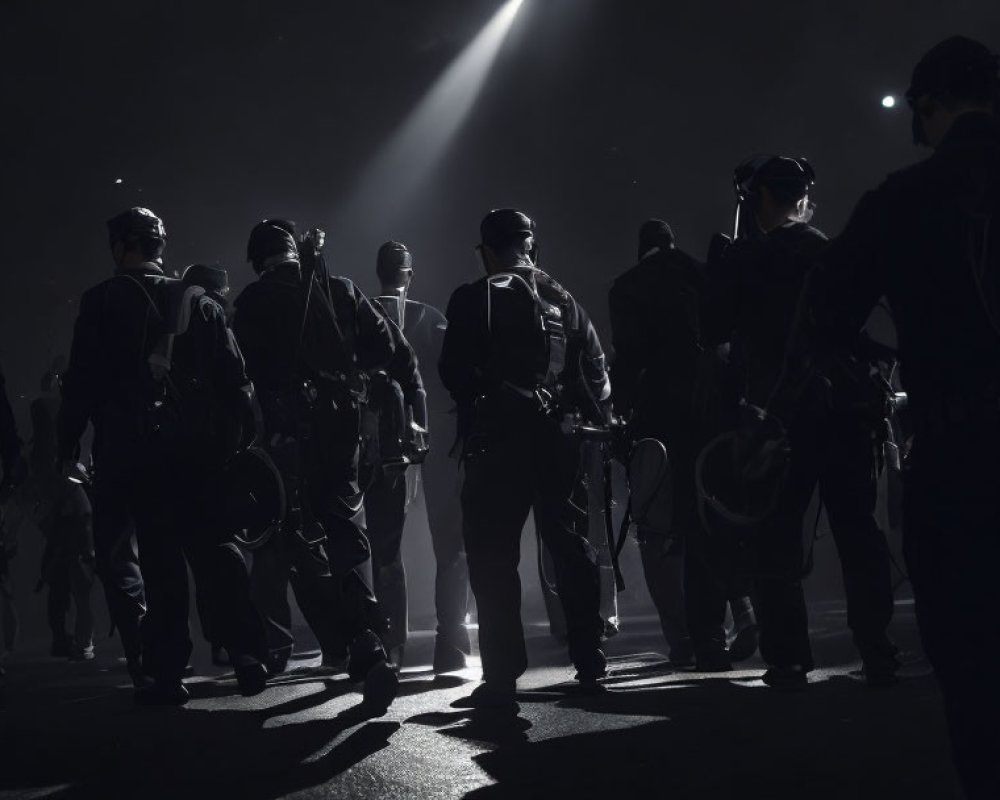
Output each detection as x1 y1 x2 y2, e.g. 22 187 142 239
0 601 960 800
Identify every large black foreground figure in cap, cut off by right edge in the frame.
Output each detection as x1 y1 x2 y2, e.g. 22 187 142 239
810 37 1000 798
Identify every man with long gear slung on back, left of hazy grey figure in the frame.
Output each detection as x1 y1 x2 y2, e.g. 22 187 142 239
233 221 395 705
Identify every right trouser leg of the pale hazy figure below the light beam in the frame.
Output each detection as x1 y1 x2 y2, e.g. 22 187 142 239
421 438 469 653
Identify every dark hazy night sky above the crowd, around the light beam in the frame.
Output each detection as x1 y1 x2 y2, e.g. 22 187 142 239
0 0 1000 406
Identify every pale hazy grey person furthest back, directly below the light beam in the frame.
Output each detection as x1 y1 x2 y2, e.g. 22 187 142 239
375 242 470 673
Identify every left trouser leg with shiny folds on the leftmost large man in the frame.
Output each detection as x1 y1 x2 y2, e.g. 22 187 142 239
93 484 146 659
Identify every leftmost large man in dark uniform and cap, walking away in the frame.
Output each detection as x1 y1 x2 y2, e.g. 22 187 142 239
58 209 266 702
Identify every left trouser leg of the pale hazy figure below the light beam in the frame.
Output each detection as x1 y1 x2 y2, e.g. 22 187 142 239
365 474 407 649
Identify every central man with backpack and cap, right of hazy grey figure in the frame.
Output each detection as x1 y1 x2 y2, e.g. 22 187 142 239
440 209 611 709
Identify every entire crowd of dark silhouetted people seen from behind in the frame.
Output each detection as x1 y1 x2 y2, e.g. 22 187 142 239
0 37 1000 797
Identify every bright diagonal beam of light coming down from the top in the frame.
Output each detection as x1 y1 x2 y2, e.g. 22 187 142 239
338 0 523 241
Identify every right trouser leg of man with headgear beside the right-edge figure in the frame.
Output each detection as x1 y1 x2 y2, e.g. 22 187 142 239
820 426 894 660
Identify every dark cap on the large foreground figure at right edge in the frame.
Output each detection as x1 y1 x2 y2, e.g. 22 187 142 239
906 36 1000 144
